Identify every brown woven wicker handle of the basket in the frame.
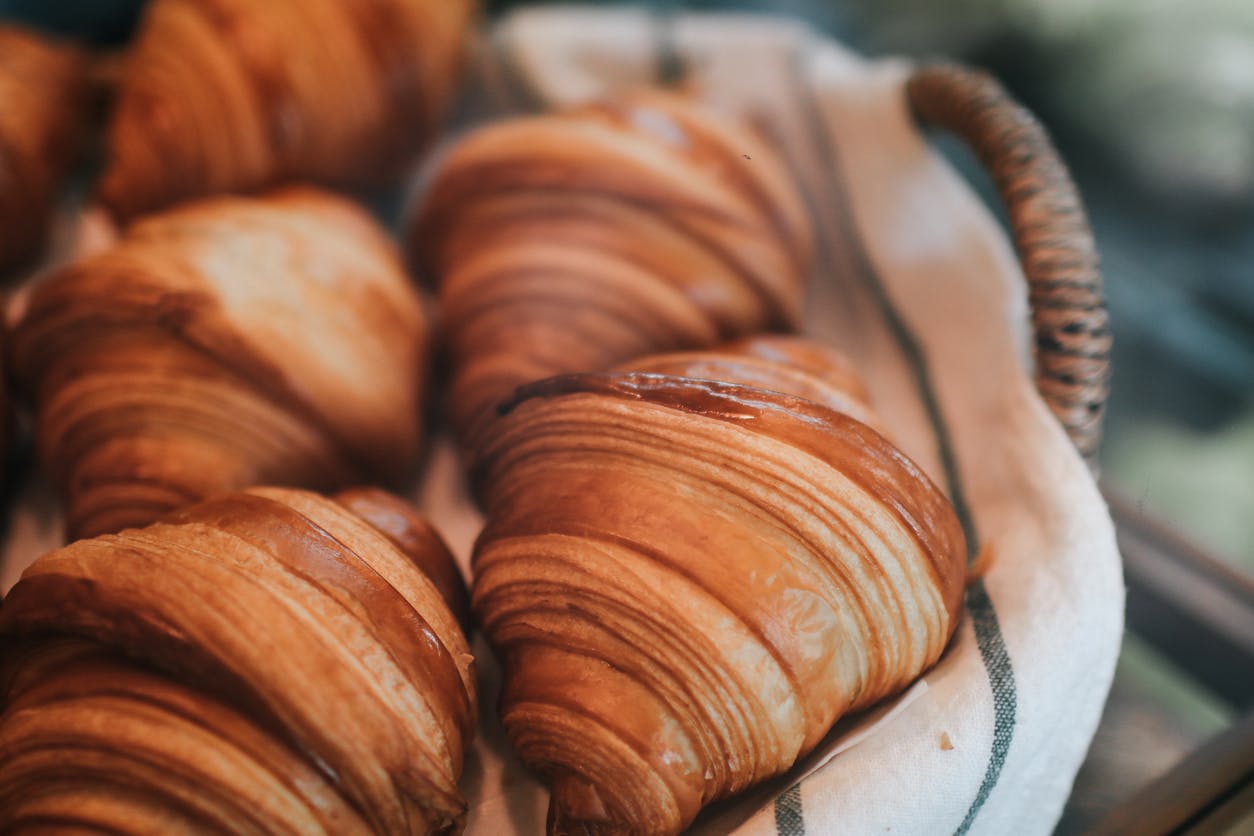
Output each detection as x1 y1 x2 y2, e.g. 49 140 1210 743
905 64 1111 459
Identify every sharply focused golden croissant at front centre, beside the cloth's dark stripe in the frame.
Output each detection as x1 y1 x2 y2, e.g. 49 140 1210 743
472 338 966 833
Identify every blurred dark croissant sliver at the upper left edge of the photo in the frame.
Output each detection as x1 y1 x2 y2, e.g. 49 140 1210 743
0 26 90 271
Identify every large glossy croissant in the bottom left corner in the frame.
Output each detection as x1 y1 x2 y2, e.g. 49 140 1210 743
0 488 475 833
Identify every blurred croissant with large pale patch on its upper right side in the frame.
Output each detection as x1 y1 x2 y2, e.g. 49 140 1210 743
13 188 429 538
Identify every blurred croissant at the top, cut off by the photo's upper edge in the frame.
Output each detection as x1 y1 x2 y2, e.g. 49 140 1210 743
99 0 474 219
